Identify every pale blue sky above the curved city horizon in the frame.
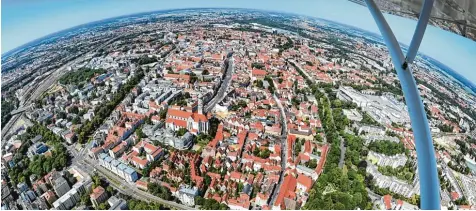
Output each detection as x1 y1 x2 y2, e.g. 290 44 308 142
1 0 476 83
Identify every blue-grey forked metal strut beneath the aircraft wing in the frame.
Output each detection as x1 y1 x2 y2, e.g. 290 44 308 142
365 0 440 210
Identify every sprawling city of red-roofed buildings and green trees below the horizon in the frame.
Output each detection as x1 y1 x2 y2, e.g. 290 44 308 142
1 5 476 210
